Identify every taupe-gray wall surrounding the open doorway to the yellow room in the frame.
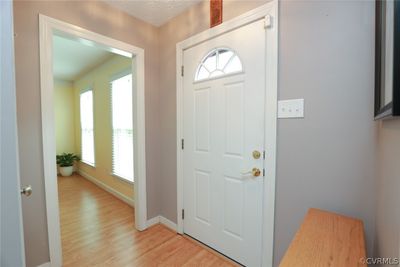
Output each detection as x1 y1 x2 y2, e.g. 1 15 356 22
14 1 160 267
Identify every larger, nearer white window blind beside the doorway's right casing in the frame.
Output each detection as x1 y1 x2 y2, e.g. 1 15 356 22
111 74 134 182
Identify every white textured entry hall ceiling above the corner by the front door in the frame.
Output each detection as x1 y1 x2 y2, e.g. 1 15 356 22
102 0 203 27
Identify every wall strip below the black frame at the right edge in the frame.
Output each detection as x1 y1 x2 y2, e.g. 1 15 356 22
375 119 400 266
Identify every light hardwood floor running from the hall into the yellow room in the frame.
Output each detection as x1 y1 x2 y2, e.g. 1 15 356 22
58 175 235 267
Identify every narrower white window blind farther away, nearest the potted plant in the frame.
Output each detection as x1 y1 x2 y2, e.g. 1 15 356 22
80 90 95 166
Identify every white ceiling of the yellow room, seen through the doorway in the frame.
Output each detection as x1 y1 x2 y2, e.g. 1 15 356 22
53 35 115 81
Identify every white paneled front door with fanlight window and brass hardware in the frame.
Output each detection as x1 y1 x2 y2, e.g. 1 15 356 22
183 20 266 266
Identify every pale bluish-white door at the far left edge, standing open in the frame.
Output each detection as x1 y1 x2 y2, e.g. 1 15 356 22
0 1 25 267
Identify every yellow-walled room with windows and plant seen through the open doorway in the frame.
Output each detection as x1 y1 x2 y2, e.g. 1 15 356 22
53 35 139 266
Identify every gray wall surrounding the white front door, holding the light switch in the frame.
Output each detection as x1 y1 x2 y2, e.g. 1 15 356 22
160 1 376 265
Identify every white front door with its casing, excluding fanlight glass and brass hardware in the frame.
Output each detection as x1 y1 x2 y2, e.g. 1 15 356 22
177 1 278 266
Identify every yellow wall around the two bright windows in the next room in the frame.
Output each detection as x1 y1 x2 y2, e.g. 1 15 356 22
74 55 133 200
